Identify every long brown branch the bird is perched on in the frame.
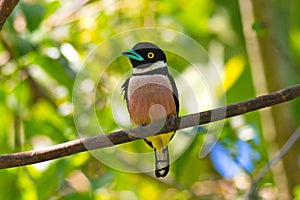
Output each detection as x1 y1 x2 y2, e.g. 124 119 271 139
0 84 300 169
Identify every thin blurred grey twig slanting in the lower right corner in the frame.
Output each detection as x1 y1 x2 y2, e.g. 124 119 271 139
247 127 300 199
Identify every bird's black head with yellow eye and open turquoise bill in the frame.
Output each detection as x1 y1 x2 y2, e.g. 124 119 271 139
122 42 166 69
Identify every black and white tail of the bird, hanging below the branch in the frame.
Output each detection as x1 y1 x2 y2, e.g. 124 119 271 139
154 146 170 177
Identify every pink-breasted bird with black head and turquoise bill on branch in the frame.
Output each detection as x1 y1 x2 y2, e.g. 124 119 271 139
121 42 179 178
